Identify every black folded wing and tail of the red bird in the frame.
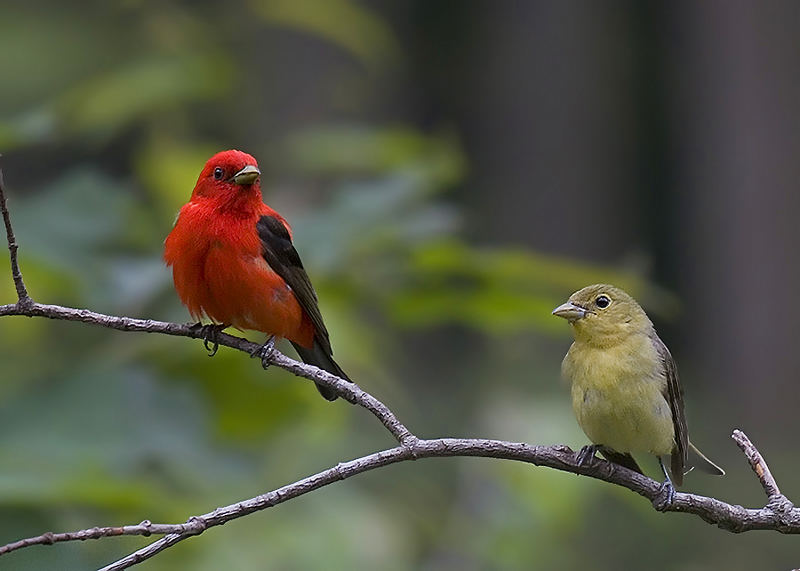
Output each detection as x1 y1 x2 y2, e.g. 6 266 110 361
256 212 350 400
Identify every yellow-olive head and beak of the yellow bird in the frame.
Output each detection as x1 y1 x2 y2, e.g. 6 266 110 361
553 284 653 346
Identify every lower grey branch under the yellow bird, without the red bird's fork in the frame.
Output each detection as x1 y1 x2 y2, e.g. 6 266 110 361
6 431 800 571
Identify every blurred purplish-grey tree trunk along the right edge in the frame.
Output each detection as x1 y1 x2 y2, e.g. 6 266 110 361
668 2 800 433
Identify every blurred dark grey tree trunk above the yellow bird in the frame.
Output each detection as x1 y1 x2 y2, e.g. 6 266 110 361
432 2 642 261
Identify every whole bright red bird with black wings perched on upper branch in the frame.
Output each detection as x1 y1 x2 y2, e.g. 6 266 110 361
164 151 350 400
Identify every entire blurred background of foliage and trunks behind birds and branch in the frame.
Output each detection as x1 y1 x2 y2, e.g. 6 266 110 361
0 0 800 571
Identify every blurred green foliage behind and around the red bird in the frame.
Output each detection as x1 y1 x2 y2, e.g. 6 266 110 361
0 0 788 570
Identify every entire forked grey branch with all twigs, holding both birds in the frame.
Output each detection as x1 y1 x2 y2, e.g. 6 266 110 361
0 162 800 571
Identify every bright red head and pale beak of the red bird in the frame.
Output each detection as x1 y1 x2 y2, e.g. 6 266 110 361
192 150 261 201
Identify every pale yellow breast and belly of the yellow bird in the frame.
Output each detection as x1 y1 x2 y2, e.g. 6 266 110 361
562 335 675 456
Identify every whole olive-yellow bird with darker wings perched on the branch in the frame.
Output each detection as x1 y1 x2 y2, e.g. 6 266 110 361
553 284 725 501
